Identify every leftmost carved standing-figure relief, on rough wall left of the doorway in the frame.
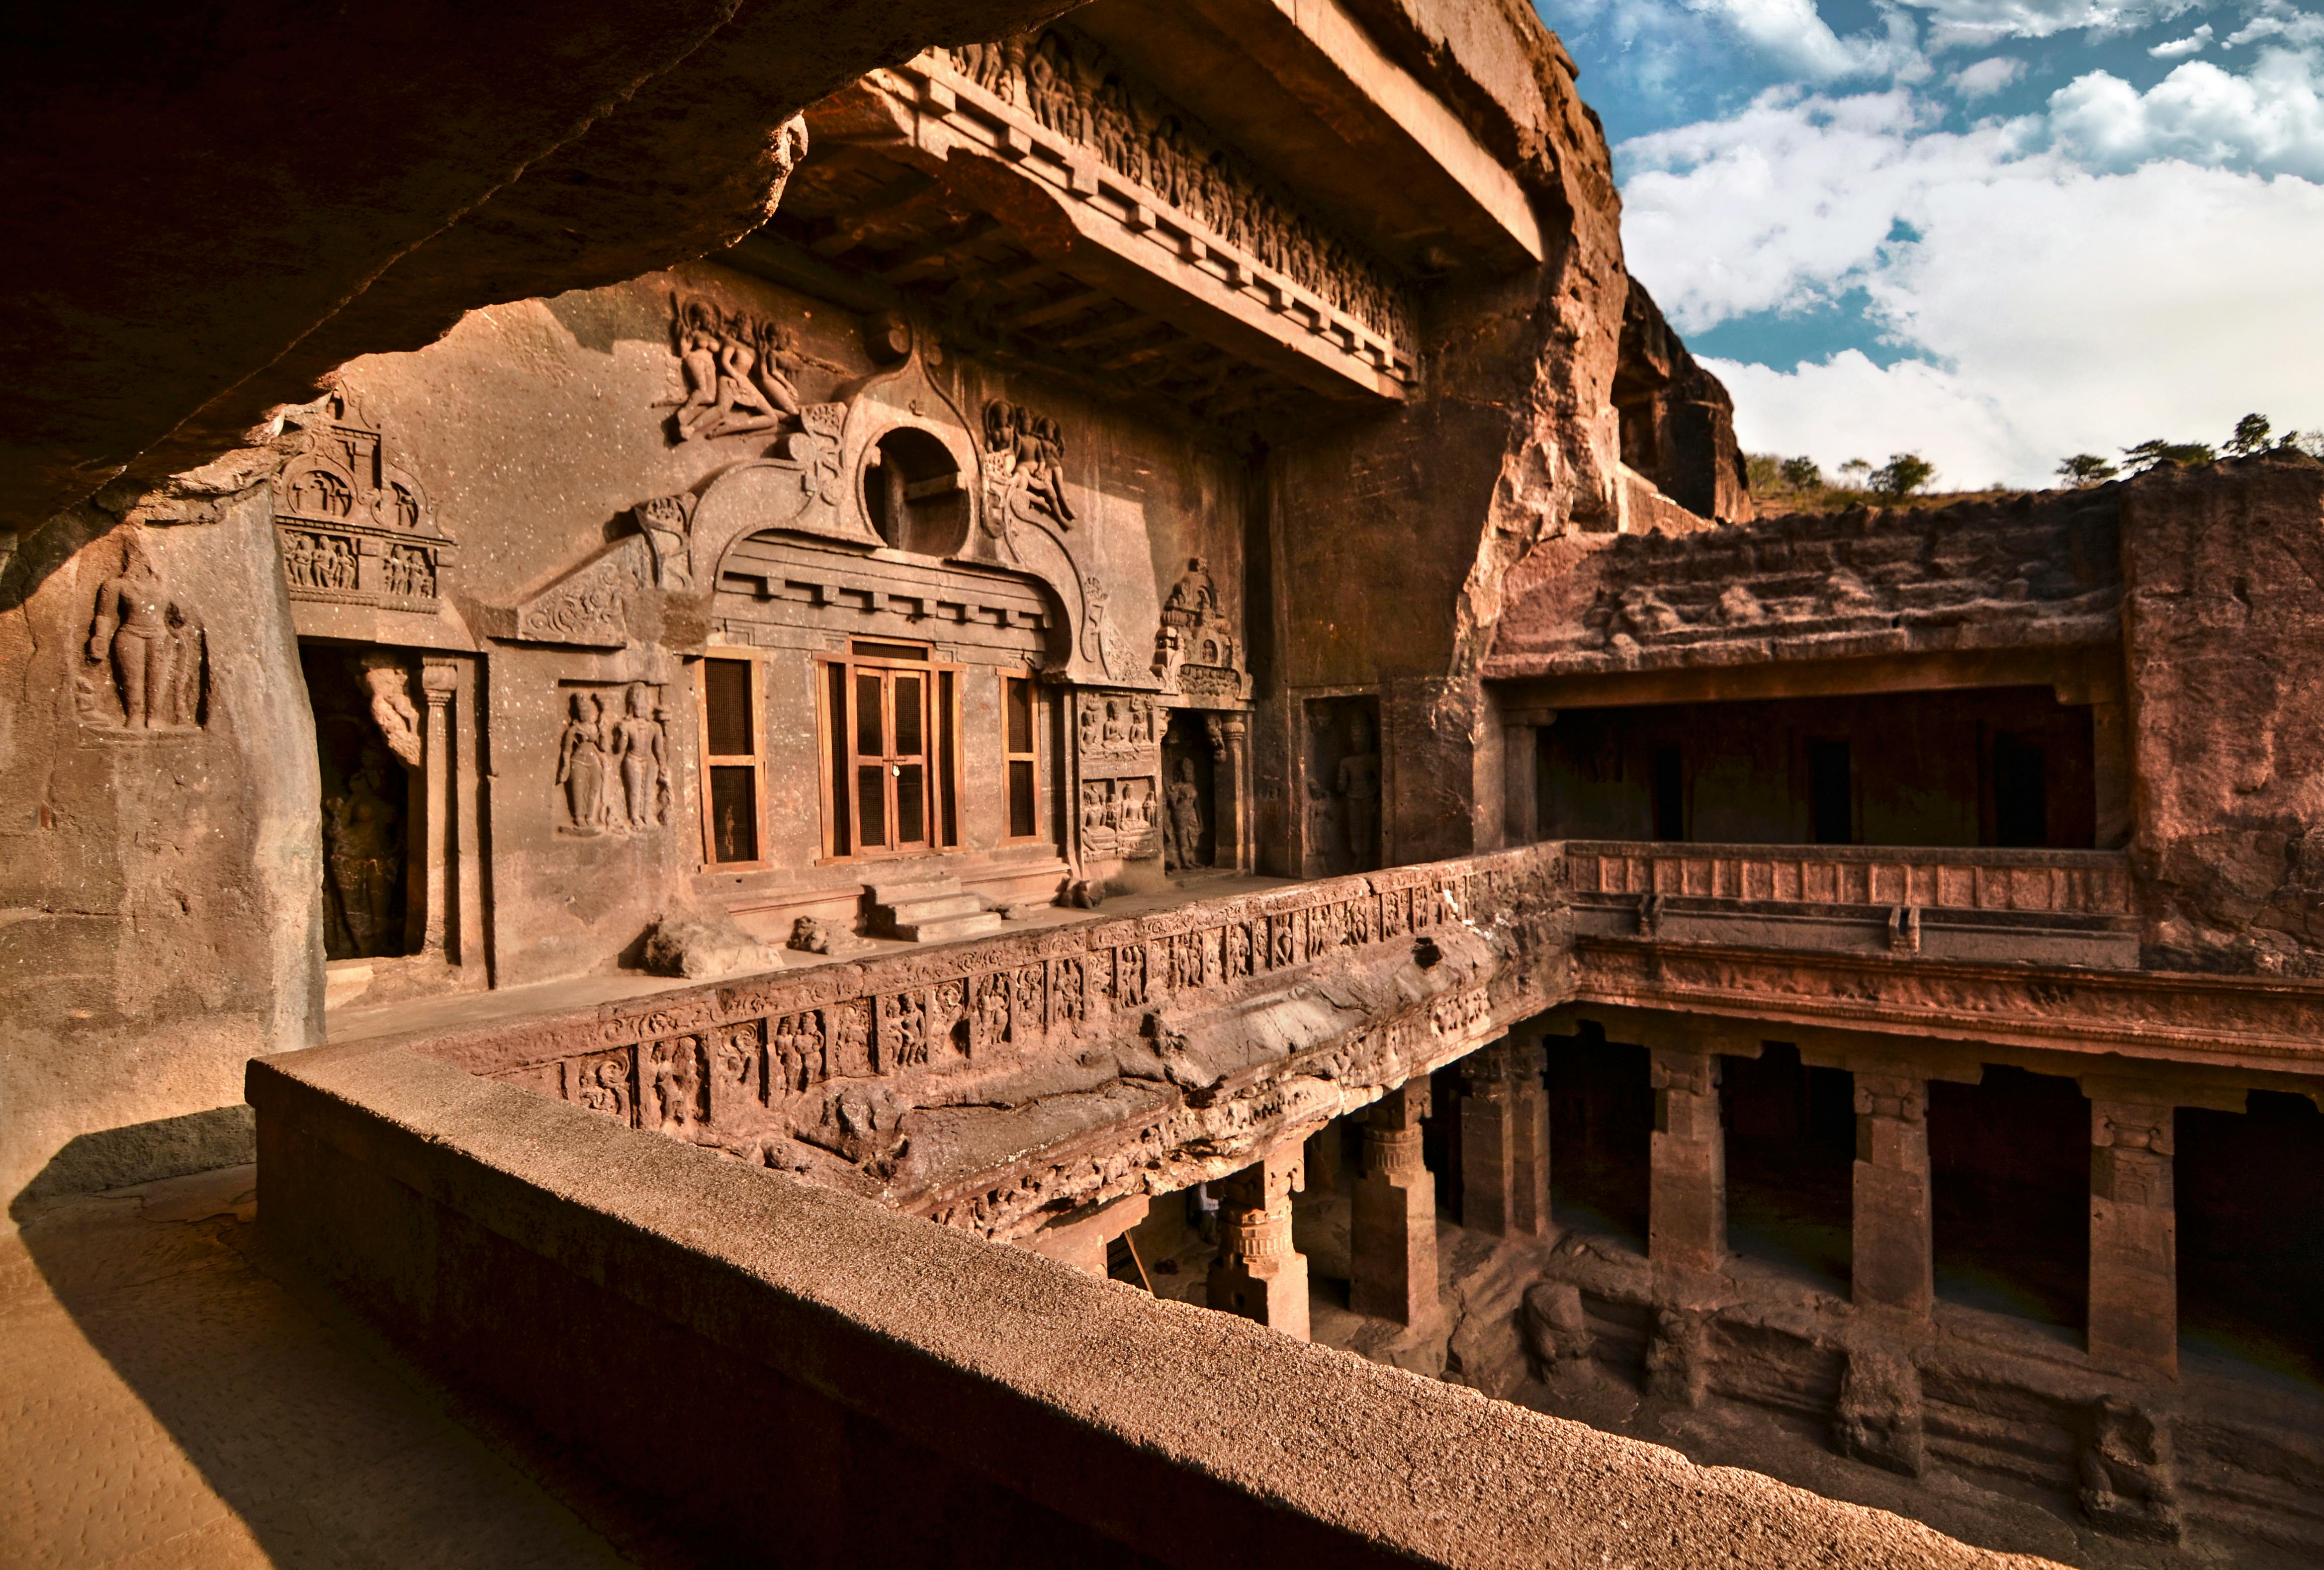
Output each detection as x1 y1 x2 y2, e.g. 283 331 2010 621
75 529 209 736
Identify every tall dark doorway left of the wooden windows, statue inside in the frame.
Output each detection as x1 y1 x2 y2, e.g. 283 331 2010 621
297 643 416 959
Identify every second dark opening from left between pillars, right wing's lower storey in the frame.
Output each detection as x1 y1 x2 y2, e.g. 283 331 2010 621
1720 1041 1857 1294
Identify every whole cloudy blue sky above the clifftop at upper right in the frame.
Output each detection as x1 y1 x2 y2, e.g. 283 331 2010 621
1536 0 2324 485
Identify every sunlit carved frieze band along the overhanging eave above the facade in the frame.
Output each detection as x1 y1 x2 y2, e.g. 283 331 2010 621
874 30 1418 385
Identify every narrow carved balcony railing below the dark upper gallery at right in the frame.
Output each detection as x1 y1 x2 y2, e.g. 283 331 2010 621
1564 841 2134 917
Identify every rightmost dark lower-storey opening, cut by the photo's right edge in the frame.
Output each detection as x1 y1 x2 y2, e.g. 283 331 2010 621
2173 1089 2324 1384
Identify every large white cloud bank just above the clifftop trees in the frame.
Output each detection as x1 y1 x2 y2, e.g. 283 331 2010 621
1624 91 2324 485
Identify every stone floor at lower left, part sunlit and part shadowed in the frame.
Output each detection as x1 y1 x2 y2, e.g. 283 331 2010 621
0 1166 651 1570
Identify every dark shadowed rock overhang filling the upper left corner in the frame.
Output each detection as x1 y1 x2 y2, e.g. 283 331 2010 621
0 0 1067 529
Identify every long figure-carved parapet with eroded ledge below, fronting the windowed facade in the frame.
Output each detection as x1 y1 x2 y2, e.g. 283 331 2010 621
402 845 1562 1235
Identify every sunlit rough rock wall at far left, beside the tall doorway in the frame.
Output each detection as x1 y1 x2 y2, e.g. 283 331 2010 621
0 476 323 1201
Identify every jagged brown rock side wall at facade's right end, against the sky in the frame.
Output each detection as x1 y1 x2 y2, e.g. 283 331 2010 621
1262 0 1629 862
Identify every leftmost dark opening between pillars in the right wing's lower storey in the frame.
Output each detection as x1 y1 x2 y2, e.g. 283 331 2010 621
1545 1024 1655 1254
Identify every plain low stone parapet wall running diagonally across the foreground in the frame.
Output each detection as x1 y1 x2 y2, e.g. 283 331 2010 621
246 1043 2045 1570
